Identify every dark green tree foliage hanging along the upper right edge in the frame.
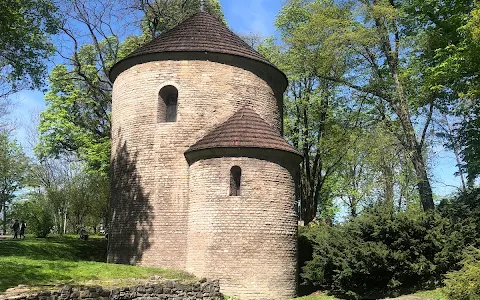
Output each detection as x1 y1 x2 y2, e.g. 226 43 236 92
407 0 480 185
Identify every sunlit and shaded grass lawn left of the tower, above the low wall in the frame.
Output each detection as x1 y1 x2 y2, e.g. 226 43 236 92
0 236 195 292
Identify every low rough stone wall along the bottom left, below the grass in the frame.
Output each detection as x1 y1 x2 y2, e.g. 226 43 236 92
0 280 223 300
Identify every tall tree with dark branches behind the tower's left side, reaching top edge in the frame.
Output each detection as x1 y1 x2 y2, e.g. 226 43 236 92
36 0 225 176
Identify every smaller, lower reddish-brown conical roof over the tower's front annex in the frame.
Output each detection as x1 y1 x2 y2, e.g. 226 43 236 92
185 106 300 155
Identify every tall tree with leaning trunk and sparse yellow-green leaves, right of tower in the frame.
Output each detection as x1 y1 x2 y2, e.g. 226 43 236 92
280 0 439 210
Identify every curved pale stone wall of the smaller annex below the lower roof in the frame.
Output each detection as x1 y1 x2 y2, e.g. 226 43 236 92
187 157 297 299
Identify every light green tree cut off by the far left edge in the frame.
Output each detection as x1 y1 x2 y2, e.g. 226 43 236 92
0 133 28 234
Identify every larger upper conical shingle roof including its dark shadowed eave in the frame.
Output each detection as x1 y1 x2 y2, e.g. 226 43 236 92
108 12 288 93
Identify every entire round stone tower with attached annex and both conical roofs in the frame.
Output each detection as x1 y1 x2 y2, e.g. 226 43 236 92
108 12 301 299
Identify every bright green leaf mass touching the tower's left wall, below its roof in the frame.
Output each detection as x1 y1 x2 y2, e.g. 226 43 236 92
35 41 117 174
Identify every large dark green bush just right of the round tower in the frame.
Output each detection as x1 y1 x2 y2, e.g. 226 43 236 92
300 206 464 298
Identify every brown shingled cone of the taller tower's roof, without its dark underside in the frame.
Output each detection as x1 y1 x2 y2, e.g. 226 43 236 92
110 12 286 82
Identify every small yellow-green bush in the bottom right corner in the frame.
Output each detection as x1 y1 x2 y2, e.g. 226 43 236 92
443 248 480 300
